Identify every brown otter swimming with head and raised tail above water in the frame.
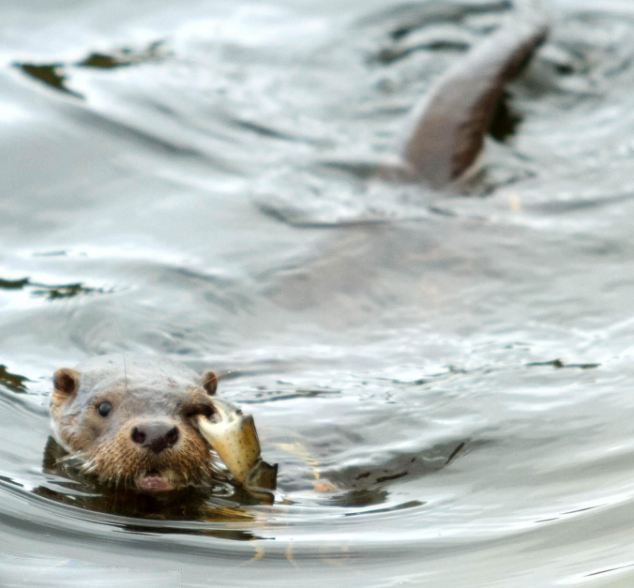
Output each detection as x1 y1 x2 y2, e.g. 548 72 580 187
50 12 547 492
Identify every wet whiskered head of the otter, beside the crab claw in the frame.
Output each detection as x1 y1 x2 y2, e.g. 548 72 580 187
50 356 217 492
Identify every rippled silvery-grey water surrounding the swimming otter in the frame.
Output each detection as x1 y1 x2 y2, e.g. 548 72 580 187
0 0 634 587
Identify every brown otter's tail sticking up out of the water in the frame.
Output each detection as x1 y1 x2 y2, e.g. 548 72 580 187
404 10 548 187
